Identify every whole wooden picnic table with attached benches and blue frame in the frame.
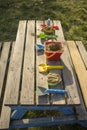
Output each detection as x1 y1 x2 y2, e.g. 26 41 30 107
0 20 87 129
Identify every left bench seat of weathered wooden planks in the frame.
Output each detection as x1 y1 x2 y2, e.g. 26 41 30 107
0 42 15 130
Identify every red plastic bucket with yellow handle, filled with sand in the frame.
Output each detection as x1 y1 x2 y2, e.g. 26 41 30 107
44 41 64 61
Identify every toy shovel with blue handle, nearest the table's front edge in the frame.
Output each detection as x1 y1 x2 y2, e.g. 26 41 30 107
38 87 68 96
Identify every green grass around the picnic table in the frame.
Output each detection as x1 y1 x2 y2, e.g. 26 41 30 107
0 0 87 130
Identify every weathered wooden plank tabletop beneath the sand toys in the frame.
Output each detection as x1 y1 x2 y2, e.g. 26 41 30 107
5 21 80 106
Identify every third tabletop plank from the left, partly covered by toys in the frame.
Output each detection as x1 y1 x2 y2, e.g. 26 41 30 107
36 21 49 105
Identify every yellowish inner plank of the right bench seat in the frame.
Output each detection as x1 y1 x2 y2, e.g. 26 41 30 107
67 41 87 108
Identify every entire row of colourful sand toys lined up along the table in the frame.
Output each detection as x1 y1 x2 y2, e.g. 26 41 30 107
36 19 67 95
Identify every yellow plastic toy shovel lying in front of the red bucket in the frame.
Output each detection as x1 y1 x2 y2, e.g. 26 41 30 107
39 63 64 72
